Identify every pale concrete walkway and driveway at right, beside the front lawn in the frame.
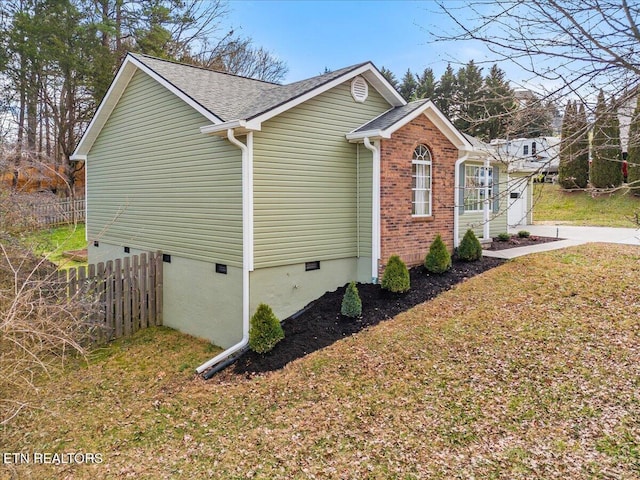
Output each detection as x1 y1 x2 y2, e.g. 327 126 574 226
482 225 640 259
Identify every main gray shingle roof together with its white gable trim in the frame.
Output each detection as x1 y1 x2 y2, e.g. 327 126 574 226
71 53 406 160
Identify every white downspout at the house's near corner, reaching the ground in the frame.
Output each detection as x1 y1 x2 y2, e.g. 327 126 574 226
196 128 253 373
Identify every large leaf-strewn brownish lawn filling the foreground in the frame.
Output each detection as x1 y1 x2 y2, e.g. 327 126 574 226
0 244 640 479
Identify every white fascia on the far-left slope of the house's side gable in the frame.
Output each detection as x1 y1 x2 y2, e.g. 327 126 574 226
70 57 136 159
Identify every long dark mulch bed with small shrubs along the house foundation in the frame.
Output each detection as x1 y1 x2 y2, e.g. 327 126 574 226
214 257 504 380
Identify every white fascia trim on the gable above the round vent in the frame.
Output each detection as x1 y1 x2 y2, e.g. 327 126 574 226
251 62 407 124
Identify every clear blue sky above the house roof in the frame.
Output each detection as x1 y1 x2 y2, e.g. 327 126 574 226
229 0 510 83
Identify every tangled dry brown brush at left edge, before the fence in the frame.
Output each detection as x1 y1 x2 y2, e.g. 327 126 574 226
0 236 91 425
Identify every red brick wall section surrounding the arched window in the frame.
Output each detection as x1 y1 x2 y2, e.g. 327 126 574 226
380 115 458 274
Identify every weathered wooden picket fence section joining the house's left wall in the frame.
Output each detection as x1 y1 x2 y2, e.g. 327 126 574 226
58 252 162 343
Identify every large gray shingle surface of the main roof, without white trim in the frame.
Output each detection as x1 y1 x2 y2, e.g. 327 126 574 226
130 54 367 122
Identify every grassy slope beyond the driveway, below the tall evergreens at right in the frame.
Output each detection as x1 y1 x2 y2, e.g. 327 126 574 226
533 183 640 228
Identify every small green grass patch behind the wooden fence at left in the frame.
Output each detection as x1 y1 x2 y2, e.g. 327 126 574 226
23 223 87 268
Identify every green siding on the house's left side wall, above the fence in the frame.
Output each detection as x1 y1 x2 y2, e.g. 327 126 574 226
87 72 242 266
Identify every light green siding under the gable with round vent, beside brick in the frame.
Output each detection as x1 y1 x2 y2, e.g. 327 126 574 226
253 82 390 268
